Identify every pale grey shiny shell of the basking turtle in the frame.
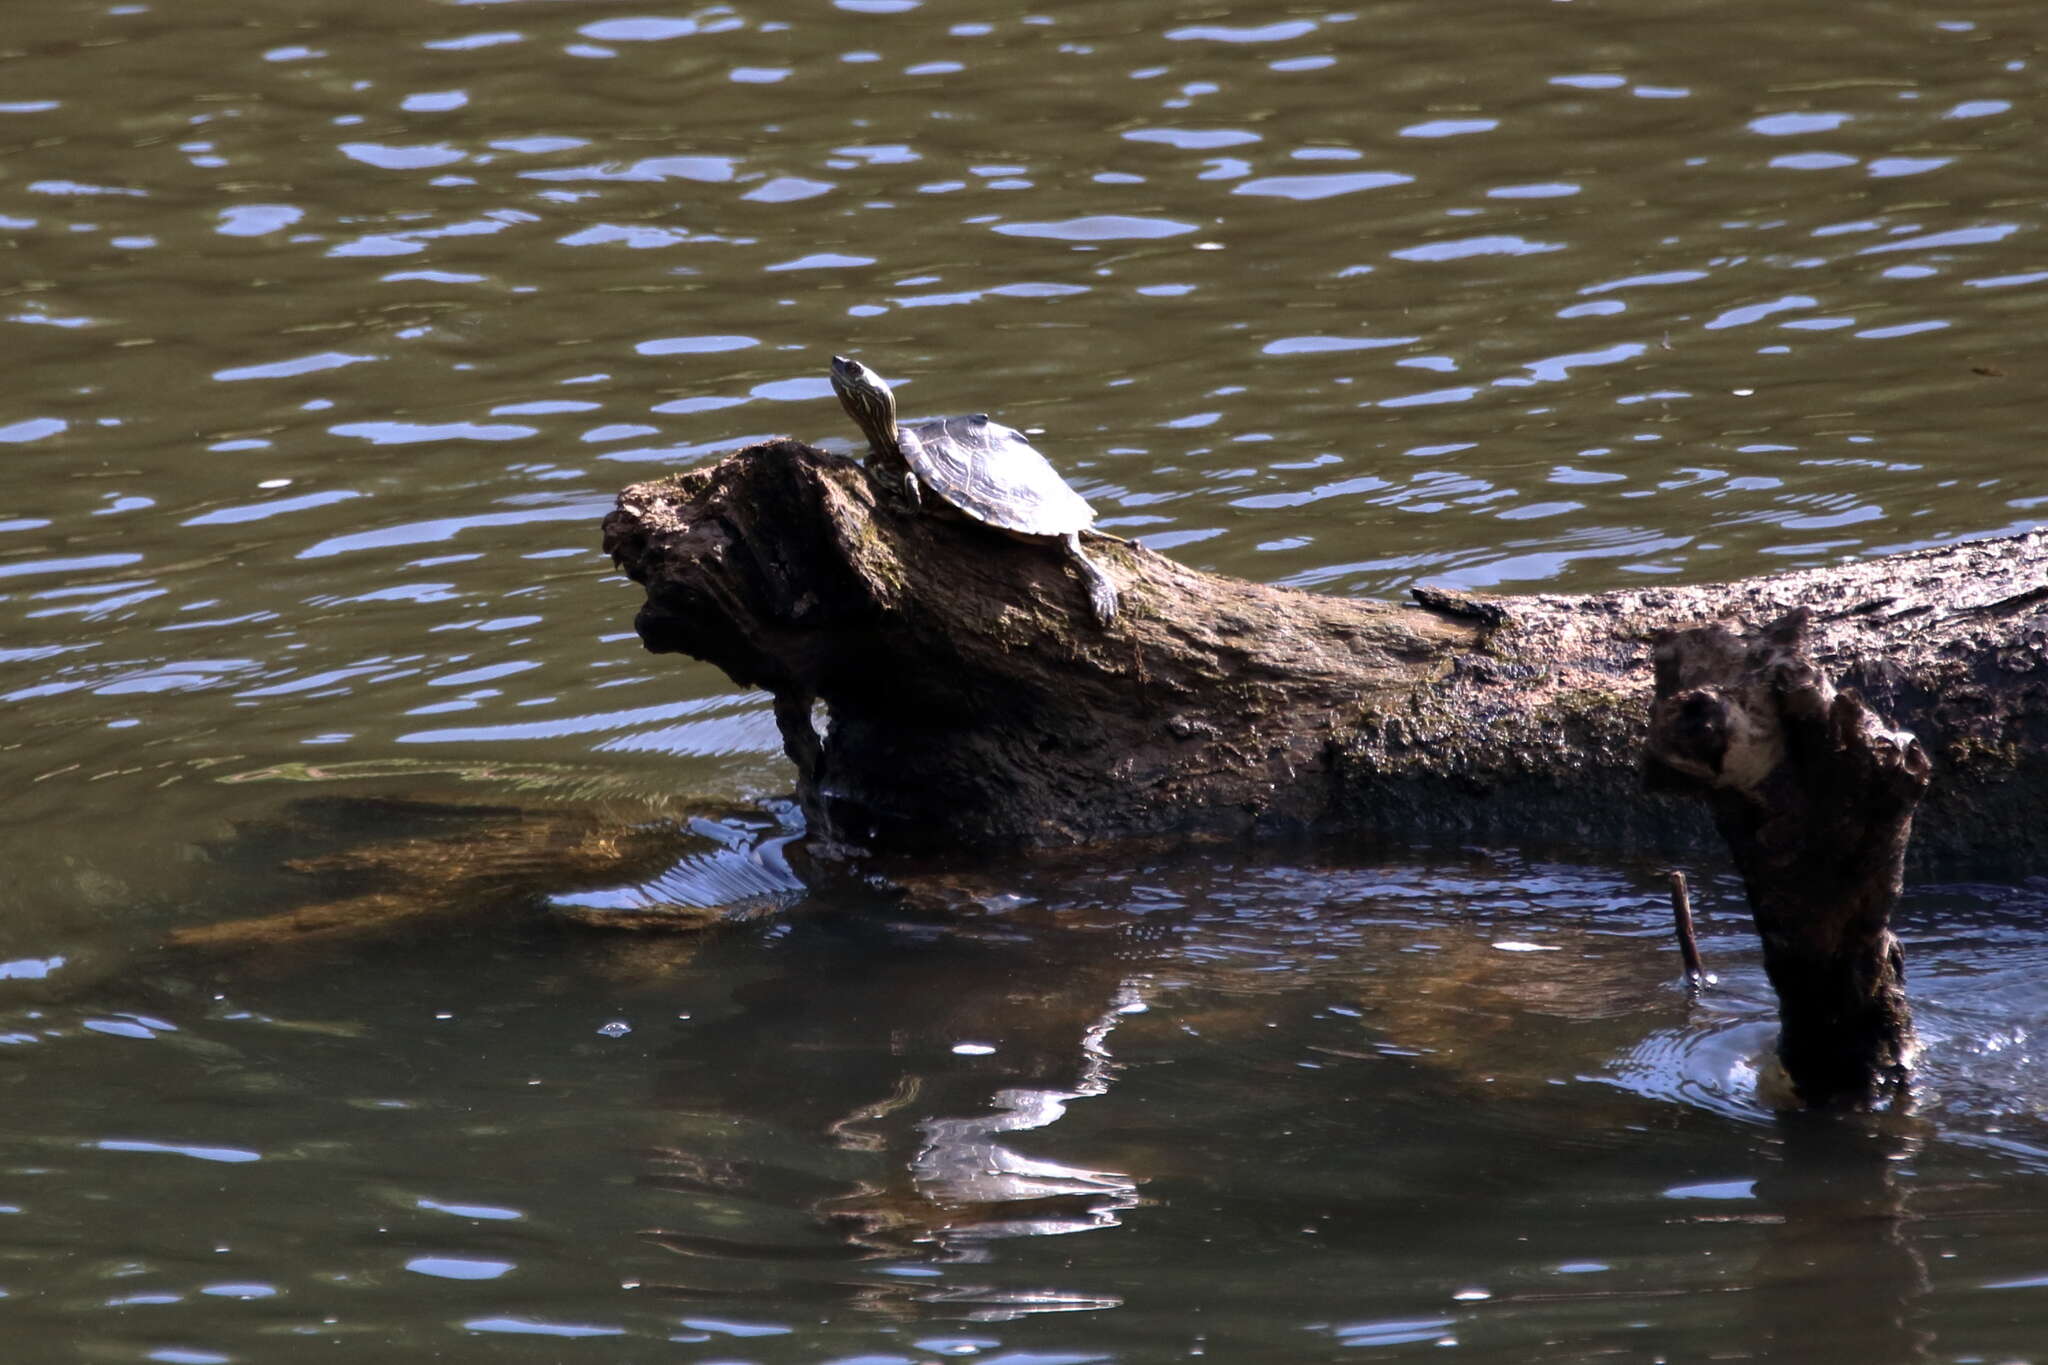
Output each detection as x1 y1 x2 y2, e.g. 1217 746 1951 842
897 413 1096 536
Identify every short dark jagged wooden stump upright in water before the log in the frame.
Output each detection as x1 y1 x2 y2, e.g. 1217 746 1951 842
1647 608 1929 1105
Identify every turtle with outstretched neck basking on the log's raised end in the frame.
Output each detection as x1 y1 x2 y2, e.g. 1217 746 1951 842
831 356 1116 626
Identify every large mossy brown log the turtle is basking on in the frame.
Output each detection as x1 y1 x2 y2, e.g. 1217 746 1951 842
604 440 2048 866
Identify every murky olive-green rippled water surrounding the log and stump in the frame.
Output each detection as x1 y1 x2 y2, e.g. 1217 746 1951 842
0 0 2048 1365
